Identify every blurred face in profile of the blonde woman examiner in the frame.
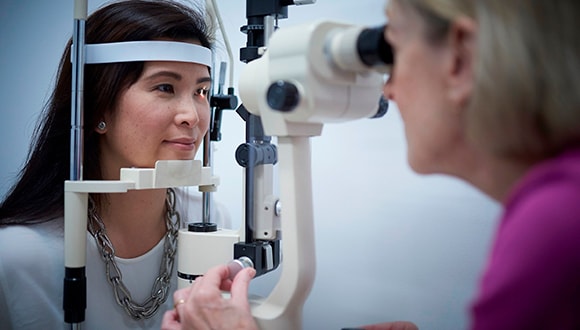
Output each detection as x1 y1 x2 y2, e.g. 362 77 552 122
384 0 461 173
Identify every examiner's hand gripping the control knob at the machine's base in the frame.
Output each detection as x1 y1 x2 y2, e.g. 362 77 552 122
161 265 258 330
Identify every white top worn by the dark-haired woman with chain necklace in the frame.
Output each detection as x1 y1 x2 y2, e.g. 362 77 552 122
0 187 231 330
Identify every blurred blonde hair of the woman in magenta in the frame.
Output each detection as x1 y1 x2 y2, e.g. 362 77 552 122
391 0 580 160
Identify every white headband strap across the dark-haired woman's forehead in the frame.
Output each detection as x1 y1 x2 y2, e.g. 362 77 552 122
85 41 212 67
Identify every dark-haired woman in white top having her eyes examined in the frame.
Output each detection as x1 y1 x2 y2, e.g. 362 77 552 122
0 0 229 329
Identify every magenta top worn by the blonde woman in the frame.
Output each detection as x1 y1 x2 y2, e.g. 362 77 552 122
471 148 580 330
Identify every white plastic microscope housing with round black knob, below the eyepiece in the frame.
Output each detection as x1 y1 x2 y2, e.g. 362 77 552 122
239 22 384 136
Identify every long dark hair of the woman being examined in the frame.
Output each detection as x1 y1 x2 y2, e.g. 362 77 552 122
0 0 213 225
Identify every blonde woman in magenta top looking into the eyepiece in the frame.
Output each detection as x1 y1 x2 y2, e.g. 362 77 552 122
164 0 580 330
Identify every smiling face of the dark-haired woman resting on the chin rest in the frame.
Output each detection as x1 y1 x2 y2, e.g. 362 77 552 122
101 62 211 175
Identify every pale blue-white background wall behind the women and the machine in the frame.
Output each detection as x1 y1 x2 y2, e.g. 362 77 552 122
0 0 499 329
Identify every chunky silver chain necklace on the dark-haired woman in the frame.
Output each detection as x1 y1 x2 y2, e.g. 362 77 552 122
88 188 181 320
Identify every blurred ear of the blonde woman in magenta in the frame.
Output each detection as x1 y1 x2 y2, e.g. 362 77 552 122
448 17 477 105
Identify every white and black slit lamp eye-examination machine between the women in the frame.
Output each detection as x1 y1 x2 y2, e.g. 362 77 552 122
63 0 393 329
